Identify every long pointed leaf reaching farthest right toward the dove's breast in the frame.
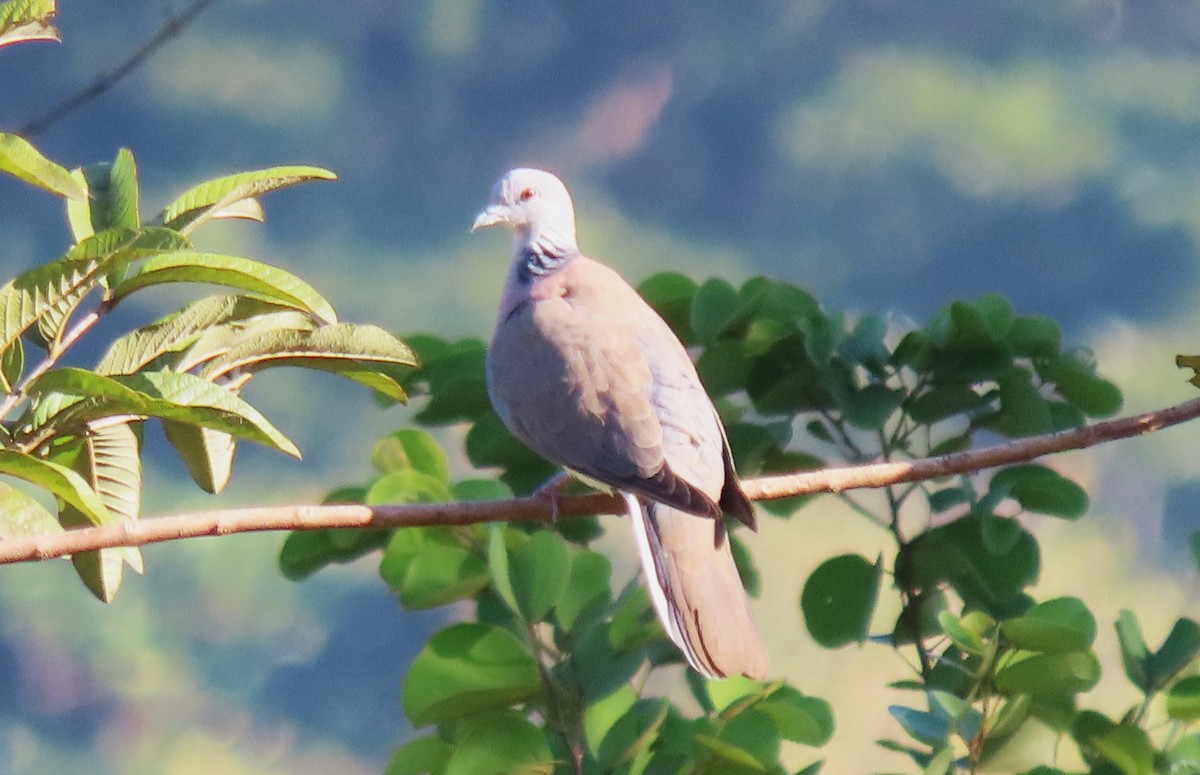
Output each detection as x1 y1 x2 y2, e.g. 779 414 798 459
202 323 418 386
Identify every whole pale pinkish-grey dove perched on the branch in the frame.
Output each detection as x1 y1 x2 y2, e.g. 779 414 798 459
474 169 767 678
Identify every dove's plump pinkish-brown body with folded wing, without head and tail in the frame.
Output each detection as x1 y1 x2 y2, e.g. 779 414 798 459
488 257 727 517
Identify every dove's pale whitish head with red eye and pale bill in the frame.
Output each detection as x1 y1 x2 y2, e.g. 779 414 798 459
470 167 577 253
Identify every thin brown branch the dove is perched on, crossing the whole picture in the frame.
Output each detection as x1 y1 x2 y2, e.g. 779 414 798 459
0 398 1200 564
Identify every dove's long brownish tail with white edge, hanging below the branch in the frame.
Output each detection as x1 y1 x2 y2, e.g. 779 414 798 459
625 494 768 679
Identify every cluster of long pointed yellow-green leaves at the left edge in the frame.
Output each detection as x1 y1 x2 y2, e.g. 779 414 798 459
0 21 416 601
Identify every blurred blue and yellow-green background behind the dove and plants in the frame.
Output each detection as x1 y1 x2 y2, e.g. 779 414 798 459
0 0 1200 775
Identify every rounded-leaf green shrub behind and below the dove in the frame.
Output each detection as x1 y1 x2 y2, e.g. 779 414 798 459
281 268 1200 773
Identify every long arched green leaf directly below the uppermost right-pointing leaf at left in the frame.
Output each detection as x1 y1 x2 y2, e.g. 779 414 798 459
112 251 337 324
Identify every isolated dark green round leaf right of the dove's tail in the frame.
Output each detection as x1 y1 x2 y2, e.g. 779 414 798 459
800 554 881 649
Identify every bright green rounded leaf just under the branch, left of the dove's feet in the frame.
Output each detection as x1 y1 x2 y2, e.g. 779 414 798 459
379 528 491 609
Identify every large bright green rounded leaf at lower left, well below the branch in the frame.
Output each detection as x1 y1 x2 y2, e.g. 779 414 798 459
401 623 541 727
